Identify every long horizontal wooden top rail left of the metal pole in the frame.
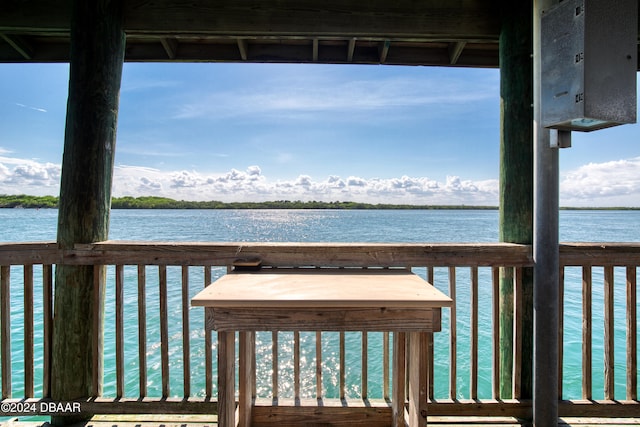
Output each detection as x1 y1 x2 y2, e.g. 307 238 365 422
0 241 532 267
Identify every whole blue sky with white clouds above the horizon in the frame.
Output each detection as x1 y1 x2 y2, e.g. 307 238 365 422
0 63 640 206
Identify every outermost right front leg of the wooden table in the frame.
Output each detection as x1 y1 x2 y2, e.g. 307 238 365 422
408 332 428 427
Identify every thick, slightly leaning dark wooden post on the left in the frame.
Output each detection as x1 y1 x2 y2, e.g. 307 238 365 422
51 0 125 425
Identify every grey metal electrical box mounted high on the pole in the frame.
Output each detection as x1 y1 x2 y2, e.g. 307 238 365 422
541 0 638 131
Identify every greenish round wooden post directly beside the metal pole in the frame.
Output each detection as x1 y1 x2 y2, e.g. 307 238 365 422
499 0 533 399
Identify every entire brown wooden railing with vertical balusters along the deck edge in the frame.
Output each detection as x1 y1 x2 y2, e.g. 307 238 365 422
0 242 640 418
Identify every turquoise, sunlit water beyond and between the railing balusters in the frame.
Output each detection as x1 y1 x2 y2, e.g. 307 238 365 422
0 209 640 410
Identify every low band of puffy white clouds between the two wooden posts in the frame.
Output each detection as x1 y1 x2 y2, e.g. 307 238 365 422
113 165 498 205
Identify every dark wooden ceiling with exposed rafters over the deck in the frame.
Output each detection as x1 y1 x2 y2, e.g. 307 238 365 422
0 0 636 67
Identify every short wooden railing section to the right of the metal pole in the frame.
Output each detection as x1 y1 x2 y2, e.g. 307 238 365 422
559 243 640 417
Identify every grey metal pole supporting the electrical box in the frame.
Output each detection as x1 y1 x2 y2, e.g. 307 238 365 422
533 0 560 427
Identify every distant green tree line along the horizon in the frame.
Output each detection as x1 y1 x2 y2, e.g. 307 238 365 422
0 194 497 209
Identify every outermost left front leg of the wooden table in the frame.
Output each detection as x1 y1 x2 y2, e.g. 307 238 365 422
218 331 236 427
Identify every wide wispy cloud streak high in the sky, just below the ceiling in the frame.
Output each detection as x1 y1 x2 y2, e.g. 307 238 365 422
174 70 498 120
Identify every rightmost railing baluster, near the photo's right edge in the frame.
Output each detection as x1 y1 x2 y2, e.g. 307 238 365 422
627 266 638 400
